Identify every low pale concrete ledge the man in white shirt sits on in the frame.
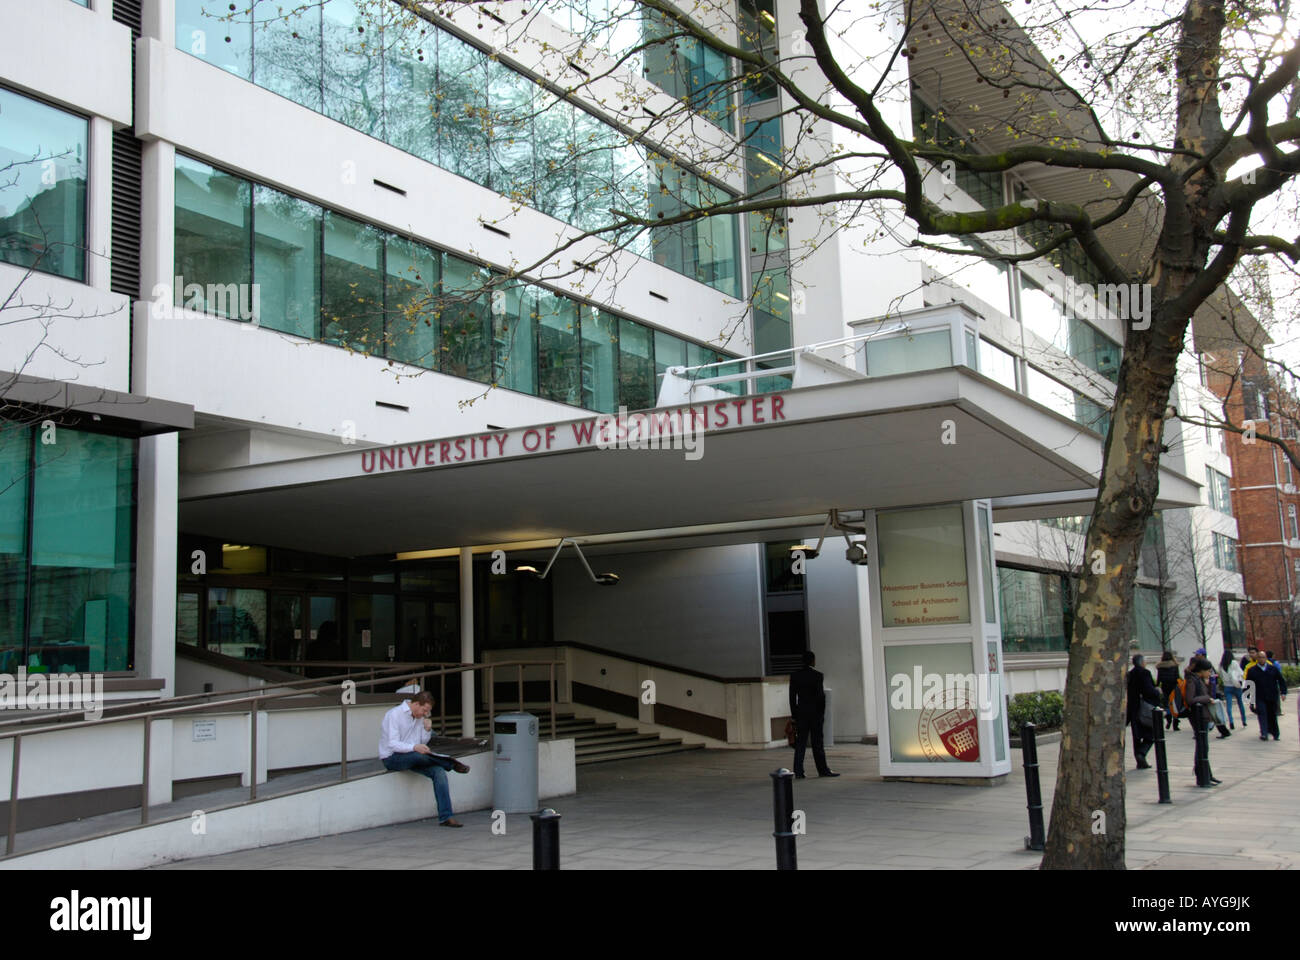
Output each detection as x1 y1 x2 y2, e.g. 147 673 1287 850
0 740 577 870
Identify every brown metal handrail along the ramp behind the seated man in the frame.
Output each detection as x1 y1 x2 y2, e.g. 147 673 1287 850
0 660 562 857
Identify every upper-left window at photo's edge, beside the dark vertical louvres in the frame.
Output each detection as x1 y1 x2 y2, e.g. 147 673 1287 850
0 87 88 280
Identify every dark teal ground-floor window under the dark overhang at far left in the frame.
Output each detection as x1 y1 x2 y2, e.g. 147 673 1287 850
0 421 135 674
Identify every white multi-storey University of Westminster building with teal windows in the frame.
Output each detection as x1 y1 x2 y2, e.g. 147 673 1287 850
0 0 1240 858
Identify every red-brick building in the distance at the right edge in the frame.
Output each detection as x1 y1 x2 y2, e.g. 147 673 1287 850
1201 350 1300 660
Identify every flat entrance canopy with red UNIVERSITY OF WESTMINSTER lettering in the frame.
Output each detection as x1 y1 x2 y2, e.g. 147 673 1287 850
181 367 1199 557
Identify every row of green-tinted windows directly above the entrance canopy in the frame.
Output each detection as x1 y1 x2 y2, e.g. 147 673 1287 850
174 156 740 412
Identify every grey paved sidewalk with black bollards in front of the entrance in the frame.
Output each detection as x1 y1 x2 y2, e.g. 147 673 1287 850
159 710 1300 870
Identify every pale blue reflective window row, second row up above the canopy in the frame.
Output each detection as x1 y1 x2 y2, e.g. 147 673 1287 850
176 0 740 297
